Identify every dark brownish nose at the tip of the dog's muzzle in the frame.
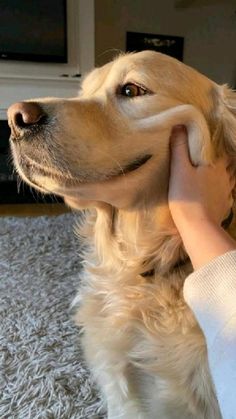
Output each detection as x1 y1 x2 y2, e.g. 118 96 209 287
8 102 46 138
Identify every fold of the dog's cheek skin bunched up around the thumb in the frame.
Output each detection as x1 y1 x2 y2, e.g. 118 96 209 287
137 105 215 165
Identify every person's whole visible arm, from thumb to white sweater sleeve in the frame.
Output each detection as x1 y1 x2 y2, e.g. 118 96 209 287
169 129 236 419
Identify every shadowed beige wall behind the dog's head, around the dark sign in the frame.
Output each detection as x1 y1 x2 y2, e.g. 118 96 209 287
95 0 236 87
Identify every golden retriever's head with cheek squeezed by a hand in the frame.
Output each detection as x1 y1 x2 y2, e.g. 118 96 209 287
8 51 236 210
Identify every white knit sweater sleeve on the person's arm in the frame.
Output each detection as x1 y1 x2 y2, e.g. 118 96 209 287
184 250 236 419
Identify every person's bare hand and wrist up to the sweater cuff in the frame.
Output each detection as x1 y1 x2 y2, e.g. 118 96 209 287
169 128 236 269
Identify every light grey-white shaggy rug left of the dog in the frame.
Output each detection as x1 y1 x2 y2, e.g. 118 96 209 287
0 214 103 419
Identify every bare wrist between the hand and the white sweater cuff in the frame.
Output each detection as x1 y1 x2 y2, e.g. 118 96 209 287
178 218 236 270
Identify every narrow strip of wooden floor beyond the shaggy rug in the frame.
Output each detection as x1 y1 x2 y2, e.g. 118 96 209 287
0 204 70 217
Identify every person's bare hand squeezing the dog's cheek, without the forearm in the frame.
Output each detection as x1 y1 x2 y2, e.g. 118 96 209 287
168 126 235 234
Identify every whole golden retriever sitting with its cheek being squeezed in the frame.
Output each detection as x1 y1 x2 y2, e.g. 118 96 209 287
8 51 236 419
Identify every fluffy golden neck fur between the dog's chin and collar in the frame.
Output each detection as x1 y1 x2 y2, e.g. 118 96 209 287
78 206 186 275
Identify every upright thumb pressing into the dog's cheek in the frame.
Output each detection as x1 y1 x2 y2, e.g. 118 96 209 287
170 125 192 168
